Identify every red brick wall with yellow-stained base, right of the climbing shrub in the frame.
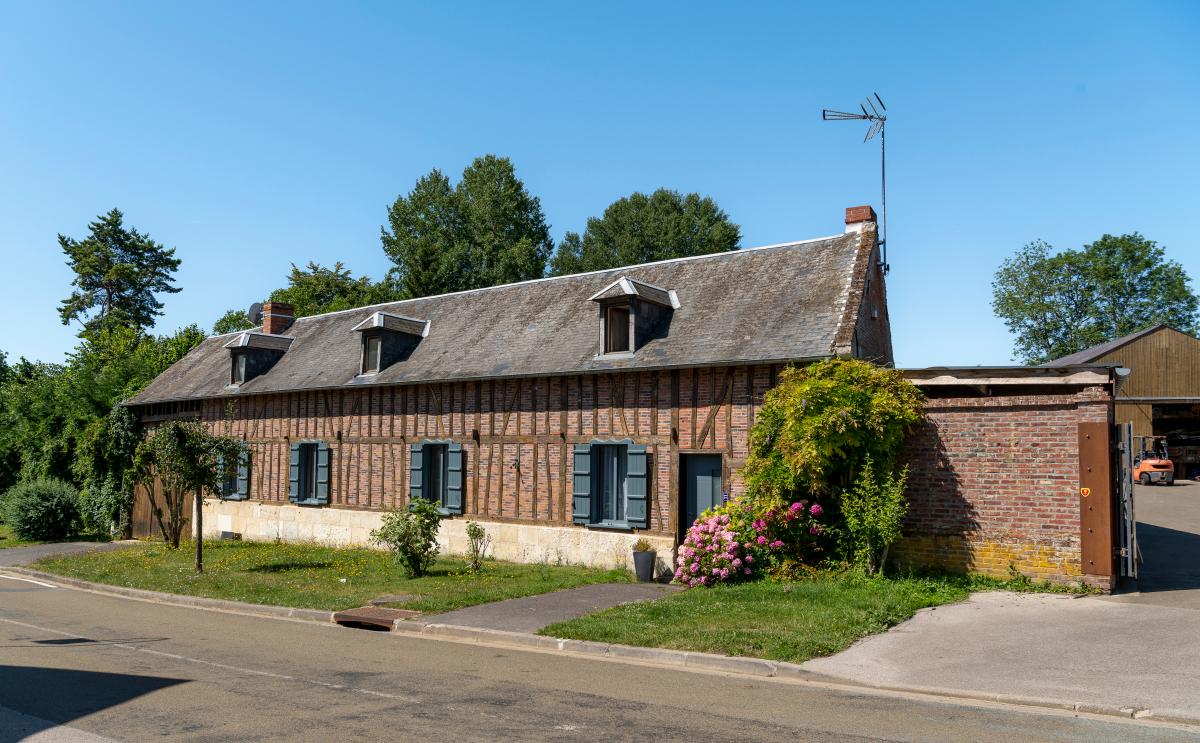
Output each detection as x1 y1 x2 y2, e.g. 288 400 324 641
895 387 1111 581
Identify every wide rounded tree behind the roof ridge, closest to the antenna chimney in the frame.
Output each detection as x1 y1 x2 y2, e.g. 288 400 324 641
550 188 742 276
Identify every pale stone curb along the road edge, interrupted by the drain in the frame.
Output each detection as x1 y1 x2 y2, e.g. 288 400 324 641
9 567 1200 727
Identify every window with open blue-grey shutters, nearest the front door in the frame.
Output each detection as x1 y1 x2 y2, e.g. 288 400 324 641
571 439 648 528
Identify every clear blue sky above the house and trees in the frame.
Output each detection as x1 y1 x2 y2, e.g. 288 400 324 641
0 0 1200 366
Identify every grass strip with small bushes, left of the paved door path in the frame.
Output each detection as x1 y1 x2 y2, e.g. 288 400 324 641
31 541 629 612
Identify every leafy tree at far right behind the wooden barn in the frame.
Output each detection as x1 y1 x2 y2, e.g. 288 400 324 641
991 233 1200 364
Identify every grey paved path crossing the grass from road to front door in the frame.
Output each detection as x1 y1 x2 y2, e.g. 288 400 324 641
412 583 679 633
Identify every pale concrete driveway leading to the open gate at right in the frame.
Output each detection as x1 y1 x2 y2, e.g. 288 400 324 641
802 593 1200 720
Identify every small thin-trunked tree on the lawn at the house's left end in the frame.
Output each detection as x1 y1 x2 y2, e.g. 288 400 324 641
134 420 241 573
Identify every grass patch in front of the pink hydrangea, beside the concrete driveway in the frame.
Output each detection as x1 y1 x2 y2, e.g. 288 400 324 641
539 574 1070 663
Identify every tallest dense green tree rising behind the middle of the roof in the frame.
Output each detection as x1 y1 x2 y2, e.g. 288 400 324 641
380 155 553 296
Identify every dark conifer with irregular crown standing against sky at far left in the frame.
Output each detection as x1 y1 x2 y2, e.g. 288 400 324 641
59 209 180 332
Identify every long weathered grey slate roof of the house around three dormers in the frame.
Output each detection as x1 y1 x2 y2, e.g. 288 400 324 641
127 233 874 405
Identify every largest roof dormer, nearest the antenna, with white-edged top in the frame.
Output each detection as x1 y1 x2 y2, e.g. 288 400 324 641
590 276 679 356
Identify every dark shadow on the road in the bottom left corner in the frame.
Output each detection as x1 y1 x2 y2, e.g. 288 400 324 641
0 665 188 743
